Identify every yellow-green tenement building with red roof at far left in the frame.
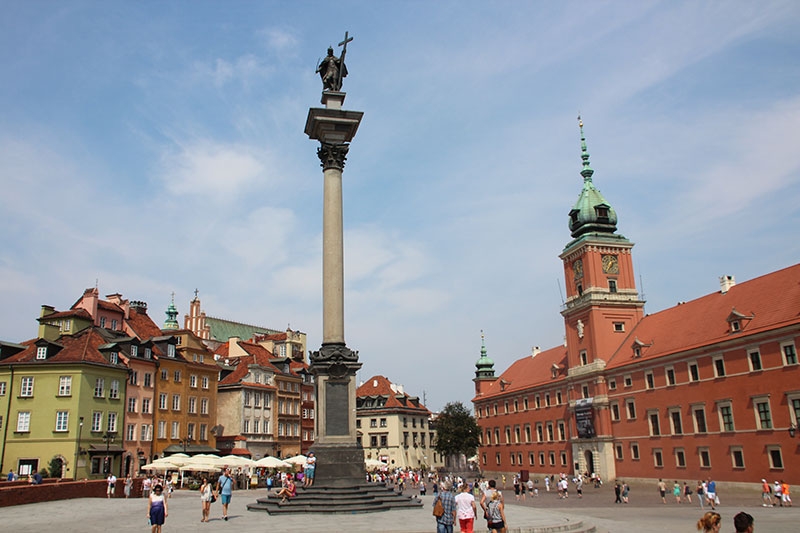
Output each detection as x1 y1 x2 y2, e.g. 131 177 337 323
0 327 128 479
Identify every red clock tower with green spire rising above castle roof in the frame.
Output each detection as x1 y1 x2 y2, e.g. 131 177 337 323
559 117 645 373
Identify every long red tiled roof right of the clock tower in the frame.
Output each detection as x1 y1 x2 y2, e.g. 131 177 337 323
608 264 800 368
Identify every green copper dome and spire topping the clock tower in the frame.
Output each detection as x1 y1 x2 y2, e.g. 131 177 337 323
569 117 617 237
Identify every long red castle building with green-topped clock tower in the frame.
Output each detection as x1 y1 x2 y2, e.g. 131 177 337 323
473 120 800 484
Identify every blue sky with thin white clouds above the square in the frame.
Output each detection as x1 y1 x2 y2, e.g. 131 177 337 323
0 0 800 409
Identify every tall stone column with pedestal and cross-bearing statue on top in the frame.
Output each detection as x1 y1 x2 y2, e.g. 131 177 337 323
305 33 365 487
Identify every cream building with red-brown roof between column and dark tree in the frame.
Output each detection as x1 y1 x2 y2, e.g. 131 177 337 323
356 376 444 469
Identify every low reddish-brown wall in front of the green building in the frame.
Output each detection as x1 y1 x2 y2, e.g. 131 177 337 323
0 478 143 507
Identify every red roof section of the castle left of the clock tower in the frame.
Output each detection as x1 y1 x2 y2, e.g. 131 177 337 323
475 345 567 400
